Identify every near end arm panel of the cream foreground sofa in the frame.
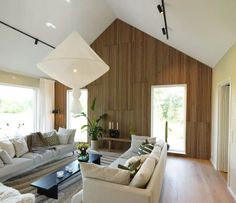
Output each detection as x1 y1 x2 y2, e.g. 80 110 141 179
83 178 151 203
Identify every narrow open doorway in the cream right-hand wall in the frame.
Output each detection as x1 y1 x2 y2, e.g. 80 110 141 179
218 82 231 182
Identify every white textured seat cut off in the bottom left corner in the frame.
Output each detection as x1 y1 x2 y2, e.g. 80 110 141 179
0 183 35 203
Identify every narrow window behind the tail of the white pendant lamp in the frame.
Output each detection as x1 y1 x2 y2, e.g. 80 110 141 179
67 89 88 142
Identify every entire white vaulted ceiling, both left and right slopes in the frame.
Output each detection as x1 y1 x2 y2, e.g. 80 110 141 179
0 0 236 77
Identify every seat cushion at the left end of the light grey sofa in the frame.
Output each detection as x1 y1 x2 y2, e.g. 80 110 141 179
0 158 34 177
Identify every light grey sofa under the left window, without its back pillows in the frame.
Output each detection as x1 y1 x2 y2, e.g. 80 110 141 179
0 144 75 182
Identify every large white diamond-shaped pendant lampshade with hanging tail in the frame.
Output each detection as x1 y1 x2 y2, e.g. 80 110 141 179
37 32 109 114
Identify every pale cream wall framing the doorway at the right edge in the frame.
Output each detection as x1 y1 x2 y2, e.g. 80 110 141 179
211 43 236 198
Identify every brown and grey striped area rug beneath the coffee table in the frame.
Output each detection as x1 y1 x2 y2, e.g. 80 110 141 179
4 152 120 203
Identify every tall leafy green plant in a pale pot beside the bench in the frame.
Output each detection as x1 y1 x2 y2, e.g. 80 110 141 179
80 98 106 150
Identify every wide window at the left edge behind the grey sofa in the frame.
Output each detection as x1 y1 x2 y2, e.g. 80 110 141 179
0 85 37 138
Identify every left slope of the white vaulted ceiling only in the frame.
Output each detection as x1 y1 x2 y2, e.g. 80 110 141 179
0 0 115 77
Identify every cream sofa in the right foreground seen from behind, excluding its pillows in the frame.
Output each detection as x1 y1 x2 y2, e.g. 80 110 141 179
72 144 167 203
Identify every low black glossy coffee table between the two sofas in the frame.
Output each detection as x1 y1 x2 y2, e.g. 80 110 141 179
31 153 102 199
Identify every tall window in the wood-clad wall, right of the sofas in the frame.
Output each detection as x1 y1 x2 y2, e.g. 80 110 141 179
151 85 186 153
